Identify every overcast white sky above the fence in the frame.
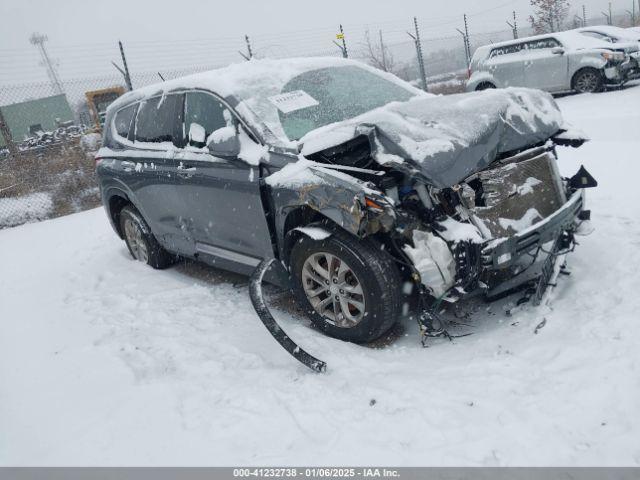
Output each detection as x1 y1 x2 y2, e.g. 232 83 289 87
0 0 633 83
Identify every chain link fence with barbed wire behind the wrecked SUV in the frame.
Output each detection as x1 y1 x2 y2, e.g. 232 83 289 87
0 9 636 229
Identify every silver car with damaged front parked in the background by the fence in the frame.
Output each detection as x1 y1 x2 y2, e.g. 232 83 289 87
467 30 637 93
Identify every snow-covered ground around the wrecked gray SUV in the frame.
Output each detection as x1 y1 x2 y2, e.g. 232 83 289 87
0 82 640 465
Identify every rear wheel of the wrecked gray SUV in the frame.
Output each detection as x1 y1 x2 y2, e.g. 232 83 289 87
120 205 175 269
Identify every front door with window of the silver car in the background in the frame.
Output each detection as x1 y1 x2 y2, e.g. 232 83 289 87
524 38 569 92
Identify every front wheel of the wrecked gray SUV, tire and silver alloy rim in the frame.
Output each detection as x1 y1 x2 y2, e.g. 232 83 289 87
290 231 401 343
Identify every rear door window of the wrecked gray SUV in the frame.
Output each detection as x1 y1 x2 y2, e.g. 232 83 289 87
135 94 184 146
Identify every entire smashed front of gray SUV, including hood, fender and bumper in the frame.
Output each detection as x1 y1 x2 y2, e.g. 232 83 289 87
265 89 588 308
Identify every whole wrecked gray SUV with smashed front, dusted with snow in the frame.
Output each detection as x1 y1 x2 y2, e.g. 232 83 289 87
96 58 595 342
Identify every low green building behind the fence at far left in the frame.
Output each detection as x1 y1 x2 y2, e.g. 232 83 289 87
0 95 74 147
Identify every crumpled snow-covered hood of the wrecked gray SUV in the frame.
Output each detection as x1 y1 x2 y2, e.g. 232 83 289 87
300 88 563 188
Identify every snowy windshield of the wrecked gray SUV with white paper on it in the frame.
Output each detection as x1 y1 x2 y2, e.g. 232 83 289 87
242 65 416 141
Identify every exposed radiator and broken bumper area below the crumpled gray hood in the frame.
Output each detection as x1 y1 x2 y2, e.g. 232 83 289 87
384 141 597 335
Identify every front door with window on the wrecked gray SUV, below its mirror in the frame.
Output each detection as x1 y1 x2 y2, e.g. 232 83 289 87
176 91 273 267
